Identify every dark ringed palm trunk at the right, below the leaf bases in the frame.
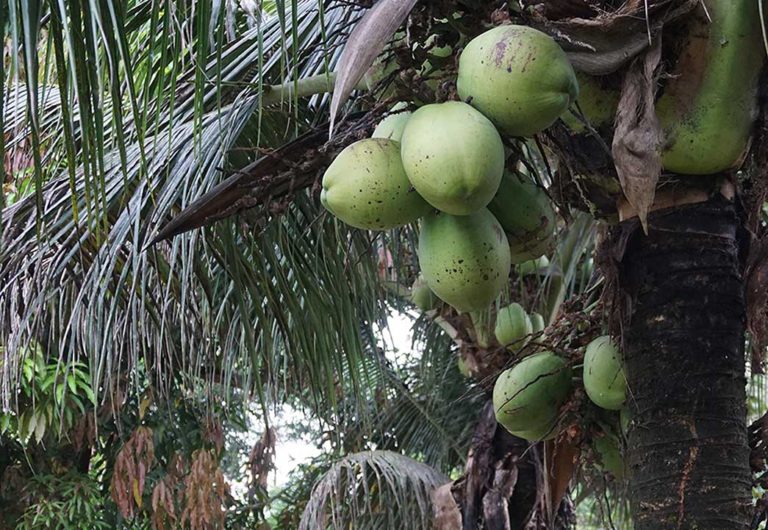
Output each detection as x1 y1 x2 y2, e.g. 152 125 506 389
615 195 751 530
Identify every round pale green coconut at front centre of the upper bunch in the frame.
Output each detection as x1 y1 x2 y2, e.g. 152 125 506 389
401 101 504 215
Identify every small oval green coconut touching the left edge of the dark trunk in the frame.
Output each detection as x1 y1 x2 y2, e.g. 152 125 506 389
584 335 627 410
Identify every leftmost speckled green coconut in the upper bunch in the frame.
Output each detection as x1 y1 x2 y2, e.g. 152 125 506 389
320 138 432 230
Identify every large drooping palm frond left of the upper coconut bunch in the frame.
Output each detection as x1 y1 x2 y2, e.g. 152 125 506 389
0 1 376 416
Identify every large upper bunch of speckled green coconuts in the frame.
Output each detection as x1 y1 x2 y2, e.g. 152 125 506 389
321 25 578 313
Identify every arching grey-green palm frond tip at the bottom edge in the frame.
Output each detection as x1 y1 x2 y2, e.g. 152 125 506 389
299 451 448 530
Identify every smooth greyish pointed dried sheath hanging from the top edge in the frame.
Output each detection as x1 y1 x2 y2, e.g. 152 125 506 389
330 0 416 136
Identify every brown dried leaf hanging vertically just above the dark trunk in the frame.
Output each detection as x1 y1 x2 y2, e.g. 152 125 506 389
612 38 663 232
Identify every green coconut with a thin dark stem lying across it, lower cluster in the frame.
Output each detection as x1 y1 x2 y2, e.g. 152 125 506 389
493 351 571 440
